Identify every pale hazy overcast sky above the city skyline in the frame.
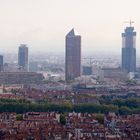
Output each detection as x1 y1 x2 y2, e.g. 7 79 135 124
0 0 140 53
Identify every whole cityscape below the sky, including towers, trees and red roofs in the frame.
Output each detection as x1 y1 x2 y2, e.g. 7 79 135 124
0 21 140 140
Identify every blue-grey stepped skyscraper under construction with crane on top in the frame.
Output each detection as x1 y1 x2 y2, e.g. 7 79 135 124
122 21 136 72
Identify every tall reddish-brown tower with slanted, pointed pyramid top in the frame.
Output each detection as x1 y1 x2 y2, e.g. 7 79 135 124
65 29 81 81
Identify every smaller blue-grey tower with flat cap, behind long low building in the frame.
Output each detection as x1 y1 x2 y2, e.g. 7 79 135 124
18 44 29 72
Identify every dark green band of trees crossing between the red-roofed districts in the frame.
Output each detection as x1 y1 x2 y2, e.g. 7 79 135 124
0 98 140 115
